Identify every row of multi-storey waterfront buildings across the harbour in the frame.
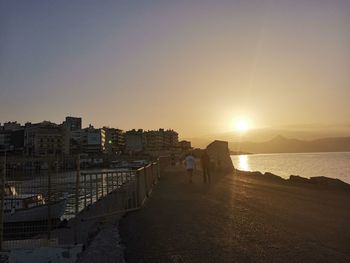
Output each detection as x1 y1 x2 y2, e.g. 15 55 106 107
0 116 186 158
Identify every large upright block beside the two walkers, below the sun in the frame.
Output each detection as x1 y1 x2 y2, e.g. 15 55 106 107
207 141 234 172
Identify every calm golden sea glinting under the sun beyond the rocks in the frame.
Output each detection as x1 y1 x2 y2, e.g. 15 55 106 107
231 152 350 184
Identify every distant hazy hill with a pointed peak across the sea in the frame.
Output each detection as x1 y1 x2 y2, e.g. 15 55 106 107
229 136 350 153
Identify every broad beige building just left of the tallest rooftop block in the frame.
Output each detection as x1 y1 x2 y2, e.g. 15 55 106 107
24 121 63 157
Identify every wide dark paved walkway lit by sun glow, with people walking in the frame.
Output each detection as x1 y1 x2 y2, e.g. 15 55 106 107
120 167 350 263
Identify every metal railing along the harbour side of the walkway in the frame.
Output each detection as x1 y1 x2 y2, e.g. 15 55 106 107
0 157 170 250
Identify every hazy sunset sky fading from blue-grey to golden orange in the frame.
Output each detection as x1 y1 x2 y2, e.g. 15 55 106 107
0 0 350 140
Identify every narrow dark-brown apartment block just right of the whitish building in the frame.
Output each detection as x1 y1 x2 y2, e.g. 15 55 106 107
102 127 125 154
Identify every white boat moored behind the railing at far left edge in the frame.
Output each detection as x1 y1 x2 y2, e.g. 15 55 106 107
3 186 67 223
